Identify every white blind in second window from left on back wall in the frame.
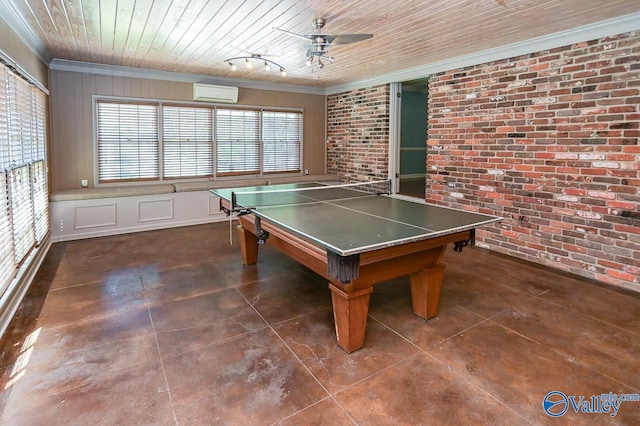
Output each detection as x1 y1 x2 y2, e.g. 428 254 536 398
162 106 213 179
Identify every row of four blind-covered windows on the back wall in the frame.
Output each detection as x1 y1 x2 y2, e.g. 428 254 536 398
96 99 303 183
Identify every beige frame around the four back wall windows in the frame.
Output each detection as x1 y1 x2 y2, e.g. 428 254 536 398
92 95 305 187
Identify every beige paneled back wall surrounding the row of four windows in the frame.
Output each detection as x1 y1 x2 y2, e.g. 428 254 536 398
49 70 326 191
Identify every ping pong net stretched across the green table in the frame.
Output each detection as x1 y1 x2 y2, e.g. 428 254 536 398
230 180 391 214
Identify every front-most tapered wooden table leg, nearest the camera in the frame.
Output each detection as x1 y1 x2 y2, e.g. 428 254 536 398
329 283 373 353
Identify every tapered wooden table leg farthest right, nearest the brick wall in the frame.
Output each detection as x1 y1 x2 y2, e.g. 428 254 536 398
410 263 445 319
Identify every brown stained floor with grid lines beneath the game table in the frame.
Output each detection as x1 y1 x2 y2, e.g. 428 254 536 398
0 223 640 426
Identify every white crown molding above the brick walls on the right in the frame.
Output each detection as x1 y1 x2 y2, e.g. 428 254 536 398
326 12 640 95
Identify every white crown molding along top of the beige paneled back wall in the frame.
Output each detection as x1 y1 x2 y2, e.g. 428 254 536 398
49 59 325 95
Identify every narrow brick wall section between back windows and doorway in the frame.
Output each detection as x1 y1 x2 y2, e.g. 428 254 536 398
327 85 389 182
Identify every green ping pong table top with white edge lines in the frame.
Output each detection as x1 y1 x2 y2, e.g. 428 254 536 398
211 183 502 256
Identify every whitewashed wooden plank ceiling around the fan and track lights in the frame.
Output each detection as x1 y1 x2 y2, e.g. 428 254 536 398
2 0 640 87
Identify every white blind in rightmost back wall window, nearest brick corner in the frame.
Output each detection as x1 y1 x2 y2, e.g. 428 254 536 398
262 111 302 173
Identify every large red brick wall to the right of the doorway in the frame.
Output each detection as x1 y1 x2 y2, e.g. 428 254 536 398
426 32 640 290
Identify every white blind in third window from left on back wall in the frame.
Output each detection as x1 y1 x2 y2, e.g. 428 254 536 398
216 109 260 176
